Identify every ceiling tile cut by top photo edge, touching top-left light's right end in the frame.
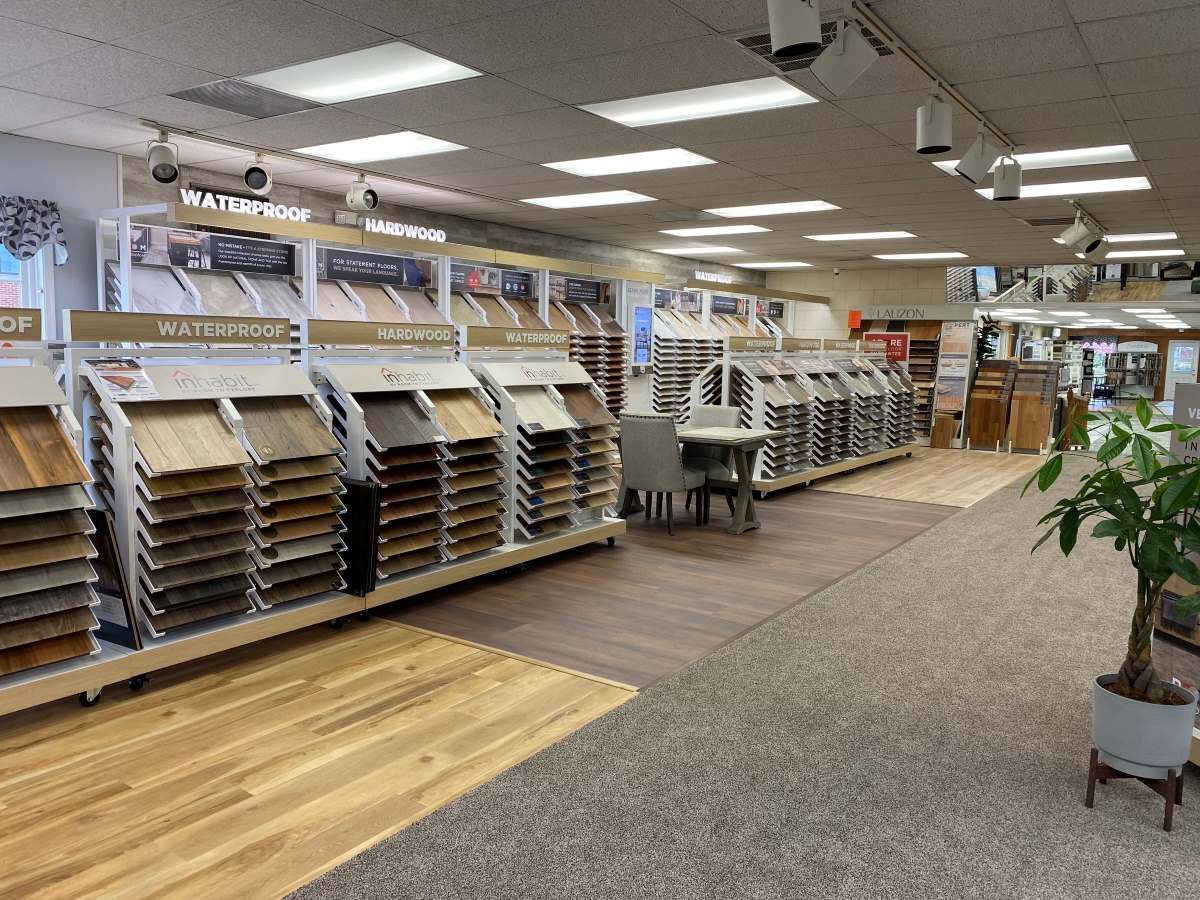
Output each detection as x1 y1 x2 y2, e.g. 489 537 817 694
407 0 708 73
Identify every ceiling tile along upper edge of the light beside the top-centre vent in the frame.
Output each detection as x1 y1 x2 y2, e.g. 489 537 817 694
508 36 766 104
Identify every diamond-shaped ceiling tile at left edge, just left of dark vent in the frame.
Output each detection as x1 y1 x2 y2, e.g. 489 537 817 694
0 44 214 107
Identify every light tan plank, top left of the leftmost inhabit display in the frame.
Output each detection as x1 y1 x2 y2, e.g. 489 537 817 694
121 400 250 475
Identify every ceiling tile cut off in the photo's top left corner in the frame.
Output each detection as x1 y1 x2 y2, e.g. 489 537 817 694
0 0 237 42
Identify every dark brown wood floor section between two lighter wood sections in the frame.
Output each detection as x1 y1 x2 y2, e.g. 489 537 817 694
380 491 954 686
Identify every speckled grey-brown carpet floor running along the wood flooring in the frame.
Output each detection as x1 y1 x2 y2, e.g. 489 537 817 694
294 463 1200 900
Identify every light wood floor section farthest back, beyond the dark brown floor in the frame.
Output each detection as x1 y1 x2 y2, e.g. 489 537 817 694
812 446 1045 506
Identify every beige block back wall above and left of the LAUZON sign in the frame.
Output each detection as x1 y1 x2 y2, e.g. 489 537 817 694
767 266 946 338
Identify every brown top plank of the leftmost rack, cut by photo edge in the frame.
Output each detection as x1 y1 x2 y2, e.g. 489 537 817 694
0 407 91 491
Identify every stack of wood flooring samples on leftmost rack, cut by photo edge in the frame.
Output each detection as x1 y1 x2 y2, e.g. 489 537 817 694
0 388 100 674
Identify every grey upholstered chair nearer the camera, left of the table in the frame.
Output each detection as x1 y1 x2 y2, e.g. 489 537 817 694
620 413 704 534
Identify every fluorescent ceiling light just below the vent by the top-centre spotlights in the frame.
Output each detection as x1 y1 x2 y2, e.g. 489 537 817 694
580 77 817 128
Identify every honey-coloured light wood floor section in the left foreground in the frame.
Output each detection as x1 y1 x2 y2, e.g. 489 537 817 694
0 619 632 900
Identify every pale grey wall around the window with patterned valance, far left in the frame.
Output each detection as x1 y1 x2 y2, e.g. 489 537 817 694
0 134 120 335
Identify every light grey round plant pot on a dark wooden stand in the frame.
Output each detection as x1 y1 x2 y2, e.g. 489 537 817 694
1092 674 1196 779
